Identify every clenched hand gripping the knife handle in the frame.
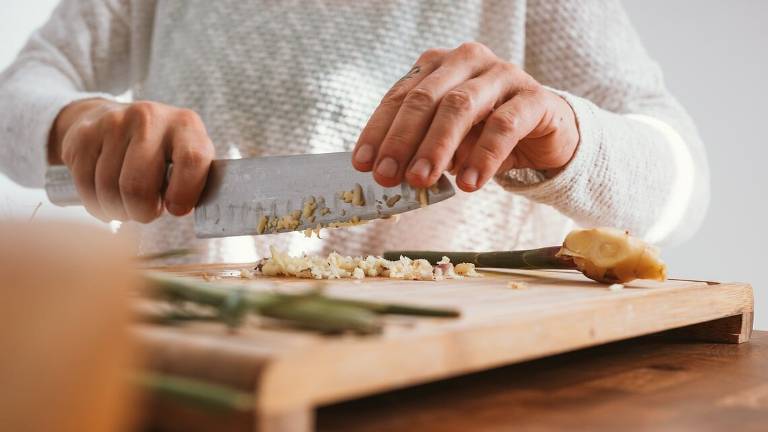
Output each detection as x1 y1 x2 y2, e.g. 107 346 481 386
48 99 214 223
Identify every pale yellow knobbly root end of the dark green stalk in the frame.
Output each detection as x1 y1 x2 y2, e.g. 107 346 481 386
557 228 667 283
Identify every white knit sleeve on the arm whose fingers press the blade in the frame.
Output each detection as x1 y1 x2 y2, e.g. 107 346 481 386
496 0 709 243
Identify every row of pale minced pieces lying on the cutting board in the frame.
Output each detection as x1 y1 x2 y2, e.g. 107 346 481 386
257 247 481 280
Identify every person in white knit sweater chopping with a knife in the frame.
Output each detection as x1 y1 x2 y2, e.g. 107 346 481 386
0 0 709 261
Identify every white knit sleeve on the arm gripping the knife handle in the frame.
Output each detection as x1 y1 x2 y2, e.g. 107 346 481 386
0 0 149 187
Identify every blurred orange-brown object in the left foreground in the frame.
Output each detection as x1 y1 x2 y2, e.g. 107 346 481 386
0 222 140 432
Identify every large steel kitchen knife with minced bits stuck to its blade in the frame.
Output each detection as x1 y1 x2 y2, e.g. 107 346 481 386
45 152 455 238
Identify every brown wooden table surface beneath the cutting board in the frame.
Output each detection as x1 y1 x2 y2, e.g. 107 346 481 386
317 332 768 432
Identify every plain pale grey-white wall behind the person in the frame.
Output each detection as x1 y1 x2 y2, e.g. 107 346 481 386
0 0 768 329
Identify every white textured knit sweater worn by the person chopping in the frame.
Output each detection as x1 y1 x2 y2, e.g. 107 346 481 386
0 0 709 261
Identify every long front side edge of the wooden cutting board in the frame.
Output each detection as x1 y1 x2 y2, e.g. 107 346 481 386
258 283 754 412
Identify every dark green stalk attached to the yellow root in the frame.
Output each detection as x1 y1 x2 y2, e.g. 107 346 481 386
384 246 573 269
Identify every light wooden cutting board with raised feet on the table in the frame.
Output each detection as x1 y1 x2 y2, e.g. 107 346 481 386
139 265 753 432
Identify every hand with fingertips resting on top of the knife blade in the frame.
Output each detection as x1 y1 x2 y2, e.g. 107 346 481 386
352 43 579 192
